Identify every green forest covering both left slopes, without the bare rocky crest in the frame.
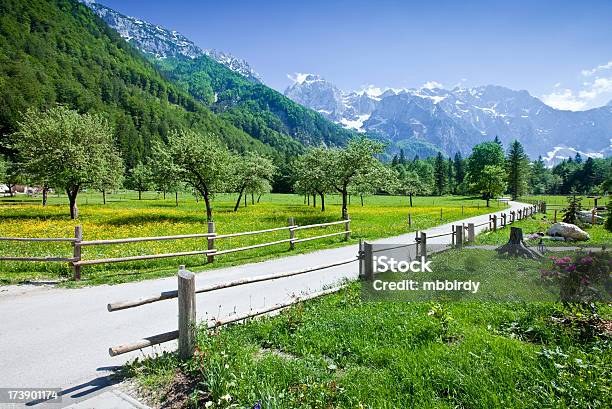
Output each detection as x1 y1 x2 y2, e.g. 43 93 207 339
0 0 350 169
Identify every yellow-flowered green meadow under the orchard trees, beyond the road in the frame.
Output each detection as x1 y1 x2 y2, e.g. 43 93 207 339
0 192 501 286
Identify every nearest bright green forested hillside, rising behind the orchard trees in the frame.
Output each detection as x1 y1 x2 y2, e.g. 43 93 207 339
0 0 278 167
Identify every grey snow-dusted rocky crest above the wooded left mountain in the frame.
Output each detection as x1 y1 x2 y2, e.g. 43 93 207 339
82 0 262 82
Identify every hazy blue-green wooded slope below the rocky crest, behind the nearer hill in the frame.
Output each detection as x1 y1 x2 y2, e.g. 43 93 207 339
153 55 353 152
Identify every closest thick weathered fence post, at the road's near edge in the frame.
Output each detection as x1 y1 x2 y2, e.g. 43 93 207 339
178 266 196 360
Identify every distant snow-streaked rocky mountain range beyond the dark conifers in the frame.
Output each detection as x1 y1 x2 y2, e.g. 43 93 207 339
285 74 612 163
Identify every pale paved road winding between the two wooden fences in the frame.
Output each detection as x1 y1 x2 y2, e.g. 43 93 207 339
0 202 525 407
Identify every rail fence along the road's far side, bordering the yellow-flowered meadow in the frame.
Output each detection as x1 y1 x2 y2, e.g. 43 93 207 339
0 218 351 280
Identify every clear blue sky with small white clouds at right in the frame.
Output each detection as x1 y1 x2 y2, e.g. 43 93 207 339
100 0 612 110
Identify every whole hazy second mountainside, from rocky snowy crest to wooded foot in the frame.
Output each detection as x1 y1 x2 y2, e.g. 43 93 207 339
89 3 354 155
